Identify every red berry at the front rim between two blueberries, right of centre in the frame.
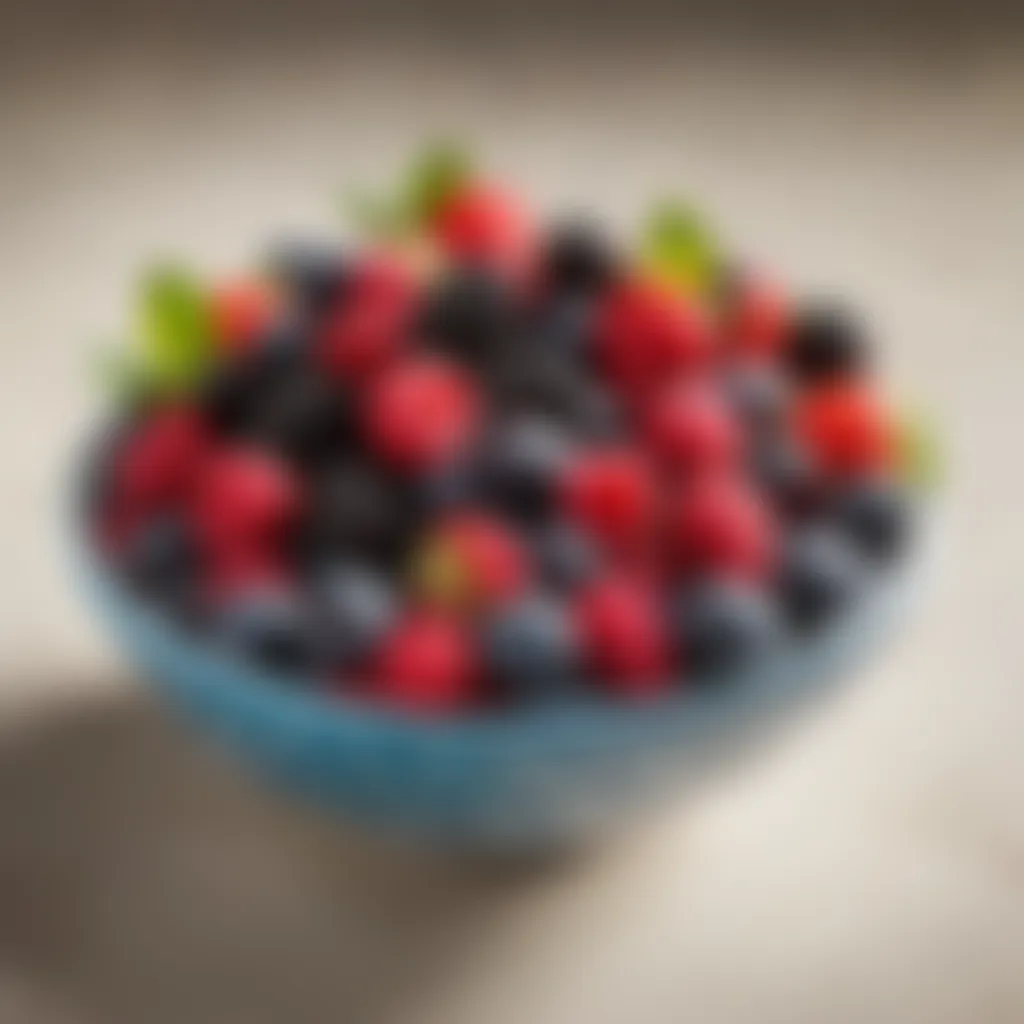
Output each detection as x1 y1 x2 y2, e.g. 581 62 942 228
577 579 670 697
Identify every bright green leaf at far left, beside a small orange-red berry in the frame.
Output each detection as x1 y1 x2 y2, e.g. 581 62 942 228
137 265 214 391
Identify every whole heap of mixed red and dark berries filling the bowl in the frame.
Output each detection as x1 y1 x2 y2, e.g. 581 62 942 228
92 149 910 714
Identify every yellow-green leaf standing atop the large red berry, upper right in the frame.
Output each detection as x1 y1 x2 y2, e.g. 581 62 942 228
640 202 721 293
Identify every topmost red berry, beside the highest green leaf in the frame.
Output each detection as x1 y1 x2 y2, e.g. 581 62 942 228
433 184 534 270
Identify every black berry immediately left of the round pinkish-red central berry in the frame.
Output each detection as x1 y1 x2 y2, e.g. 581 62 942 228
253 370 354 465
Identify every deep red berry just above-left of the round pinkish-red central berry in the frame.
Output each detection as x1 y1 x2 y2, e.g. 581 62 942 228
317 295 412 382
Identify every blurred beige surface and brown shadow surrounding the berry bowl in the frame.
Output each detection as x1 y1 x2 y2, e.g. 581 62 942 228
0 0 1024 1024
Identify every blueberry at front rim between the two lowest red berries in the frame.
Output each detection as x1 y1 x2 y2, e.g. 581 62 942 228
482 596 580 699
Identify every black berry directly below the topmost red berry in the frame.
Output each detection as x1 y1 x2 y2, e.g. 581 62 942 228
421 267 519 368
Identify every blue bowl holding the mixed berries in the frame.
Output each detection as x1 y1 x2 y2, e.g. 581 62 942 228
72 452 922 851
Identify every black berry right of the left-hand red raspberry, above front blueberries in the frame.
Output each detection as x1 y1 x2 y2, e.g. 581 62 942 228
298 458 416 566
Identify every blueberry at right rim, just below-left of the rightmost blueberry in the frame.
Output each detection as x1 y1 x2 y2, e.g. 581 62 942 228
777 524 864 630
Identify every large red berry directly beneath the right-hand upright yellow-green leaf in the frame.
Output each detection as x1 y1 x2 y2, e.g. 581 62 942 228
597 279 712 397
